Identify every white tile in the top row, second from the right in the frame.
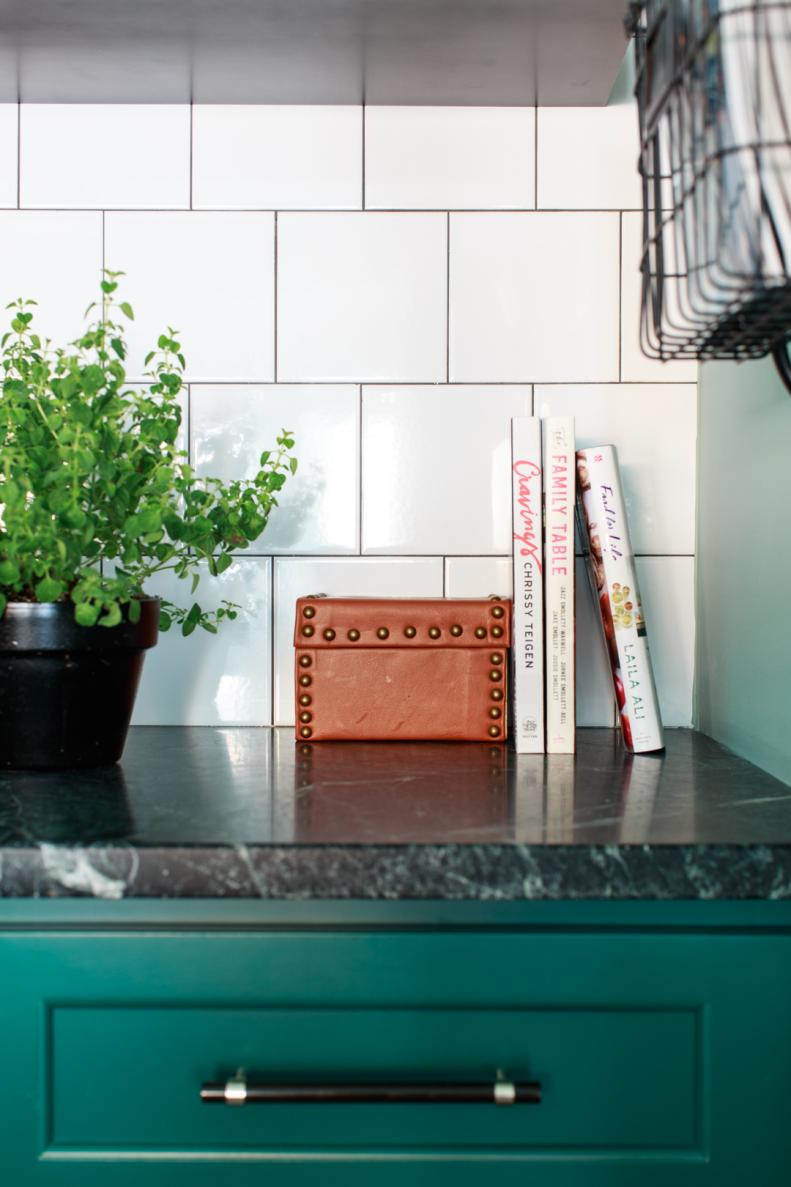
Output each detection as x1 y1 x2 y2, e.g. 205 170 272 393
366 107 536 210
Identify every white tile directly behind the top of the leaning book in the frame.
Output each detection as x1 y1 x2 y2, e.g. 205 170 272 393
536 383 697 553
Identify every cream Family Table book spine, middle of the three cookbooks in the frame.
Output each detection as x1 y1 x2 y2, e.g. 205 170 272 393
543 417 576 754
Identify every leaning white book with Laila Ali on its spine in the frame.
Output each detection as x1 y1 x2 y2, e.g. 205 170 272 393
577 445 664 754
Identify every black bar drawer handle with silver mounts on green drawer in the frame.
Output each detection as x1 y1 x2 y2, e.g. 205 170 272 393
201 1073 542 1106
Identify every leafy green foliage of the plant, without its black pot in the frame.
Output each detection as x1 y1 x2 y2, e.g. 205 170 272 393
0 272 297 635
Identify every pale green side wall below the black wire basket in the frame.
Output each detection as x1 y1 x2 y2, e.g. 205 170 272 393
696 358 791 783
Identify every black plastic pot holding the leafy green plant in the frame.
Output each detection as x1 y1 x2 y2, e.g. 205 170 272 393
0 598 159 770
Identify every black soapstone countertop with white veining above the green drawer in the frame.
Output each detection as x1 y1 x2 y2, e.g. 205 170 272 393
0 726 791 901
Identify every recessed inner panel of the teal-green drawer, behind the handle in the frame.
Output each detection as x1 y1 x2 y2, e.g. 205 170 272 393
49 1007 701 1153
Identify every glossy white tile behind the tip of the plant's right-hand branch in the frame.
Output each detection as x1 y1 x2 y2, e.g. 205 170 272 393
191 383 360 553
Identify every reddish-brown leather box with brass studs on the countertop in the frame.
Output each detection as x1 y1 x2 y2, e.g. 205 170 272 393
295 597 511 742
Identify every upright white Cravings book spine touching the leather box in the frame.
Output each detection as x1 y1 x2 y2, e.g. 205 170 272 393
511 417 544 754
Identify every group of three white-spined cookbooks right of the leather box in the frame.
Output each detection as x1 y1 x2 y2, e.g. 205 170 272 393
511 417 664 754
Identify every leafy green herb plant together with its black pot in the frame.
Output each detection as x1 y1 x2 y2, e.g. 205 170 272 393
0 272 297 768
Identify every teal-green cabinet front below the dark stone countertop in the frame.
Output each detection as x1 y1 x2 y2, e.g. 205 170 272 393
0 903 791 1187
